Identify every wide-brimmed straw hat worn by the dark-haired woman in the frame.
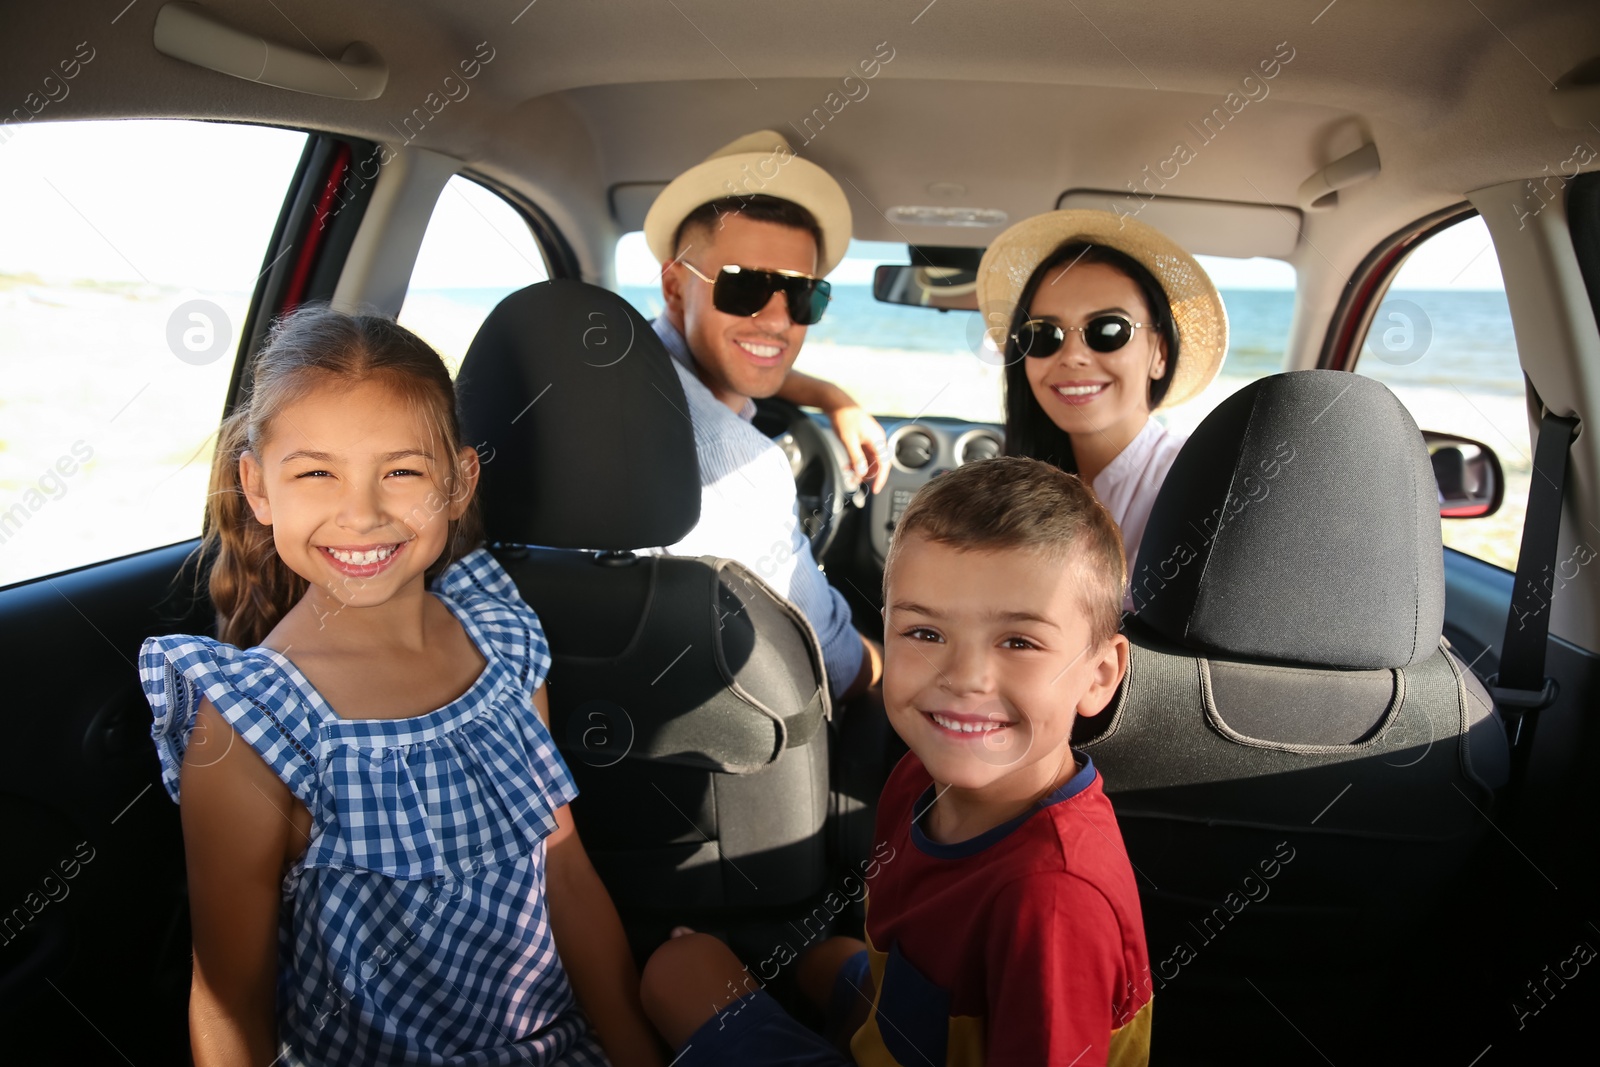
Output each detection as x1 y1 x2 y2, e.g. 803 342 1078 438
978 210 1227 406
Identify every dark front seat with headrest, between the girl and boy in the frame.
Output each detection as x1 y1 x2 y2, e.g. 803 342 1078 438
458 280 830 953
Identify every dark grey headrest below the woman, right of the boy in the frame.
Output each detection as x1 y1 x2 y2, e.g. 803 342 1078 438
1131 371 1445 669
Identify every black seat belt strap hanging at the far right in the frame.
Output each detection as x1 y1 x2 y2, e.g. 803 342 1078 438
1491 411 1578 752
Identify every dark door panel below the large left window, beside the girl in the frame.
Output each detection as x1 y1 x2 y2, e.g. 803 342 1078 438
0 541 210 1062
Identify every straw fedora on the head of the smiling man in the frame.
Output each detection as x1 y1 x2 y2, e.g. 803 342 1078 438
645 130 851 275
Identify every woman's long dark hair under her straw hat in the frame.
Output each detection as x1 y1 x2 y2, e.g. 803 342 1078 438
1005 242 1178 474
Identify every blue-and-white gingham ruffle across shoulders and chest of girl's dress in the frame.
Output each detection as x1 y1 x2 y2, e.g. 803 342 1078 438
139 550 578 880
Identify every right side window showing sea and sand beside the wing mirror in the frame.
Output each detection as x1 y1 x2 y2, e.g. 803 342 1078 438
1357 216 1533 569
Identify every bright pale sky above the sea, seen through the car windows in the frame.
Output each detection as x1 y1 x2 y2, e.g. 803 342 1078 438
0 120 1502 291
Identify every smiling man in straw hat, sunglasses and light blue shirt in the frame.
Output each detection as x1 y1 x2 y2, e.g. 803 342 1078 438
645 130 886 699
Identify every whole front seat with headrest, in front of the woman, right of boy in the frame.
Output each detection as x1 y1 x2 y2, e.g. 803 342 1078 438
1075 371 1509 1064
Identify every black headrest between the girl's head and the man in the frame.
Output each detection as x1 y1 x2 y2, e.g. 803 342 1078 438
456 280 701 549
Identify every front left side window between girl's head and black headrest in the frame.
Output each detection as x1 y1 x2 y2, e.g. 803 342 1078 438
398 174 550 373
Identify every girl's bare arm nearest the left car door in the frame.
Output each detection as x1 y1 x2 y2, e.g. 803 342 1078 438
178 701 309 1067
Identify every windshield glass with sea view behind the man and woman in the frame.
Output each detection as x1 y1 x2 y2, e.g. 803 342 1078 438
616 232 1294 430
